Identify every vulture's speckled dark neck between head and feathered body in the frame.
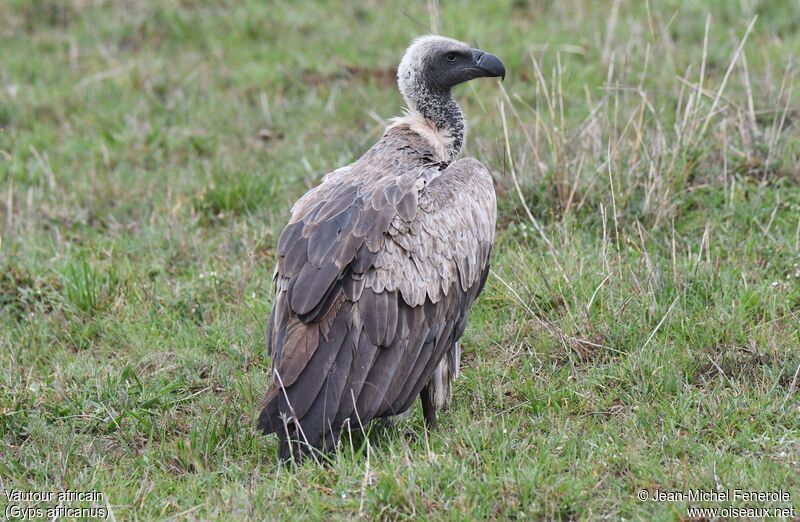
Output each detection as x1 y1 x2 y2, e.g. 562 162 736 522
406 89 465 163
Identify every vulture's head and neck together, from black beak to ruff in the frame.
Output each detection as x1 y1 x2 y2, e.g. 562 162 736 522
397 35 506 161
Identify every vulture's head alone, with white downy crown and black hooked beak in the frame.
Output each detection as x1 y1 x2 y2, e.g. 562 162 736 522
397 35 506 101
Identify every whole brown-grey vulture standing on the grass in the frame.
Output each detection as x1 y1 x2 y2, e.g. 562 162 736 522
258 35 505 460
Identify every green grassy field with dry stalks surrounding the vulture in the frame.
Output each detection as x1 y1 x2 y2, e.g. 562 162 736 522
0 0 800 520
